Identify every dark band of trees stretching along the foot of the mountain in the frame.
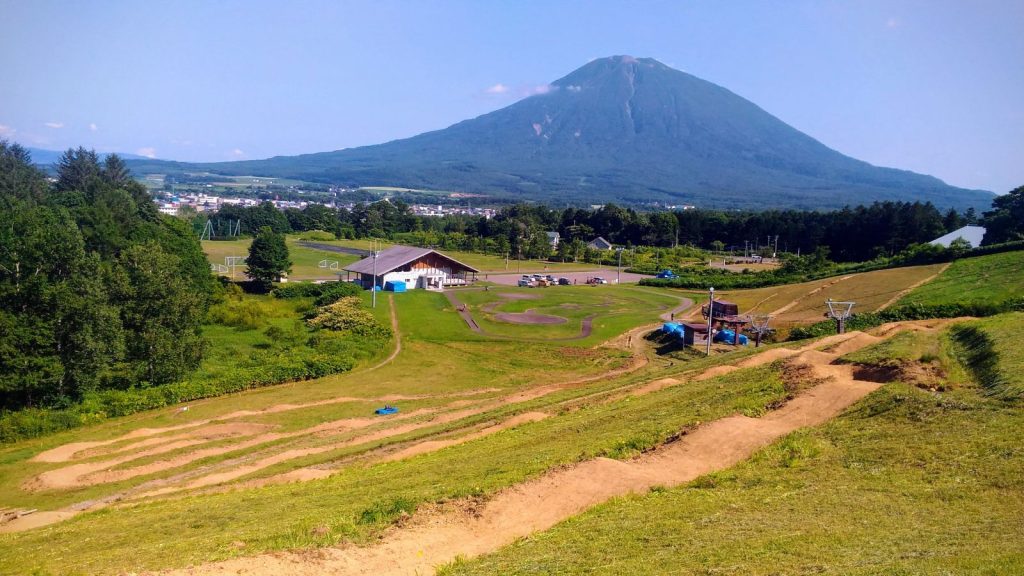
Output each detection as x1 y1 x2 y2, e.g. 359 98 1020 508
197 187 1024 262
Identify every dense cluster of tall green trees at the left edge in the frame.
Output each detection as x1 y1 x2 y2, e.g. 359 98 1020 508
0 140 216 409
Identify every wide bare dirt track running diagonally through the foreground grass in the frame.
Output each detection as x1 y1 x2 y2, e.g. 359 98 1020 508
151 325 897 576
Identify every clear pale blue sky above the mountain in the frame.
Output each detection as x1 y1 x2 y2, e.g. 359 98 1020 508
0 0 1024 193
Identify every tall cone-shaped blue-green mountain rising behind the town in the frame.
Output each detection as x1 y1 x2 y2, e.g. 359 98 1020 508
123 56 993 209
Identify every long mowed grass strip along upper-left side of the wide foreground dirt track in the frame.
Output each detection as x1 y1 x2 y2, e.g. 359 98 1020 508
0 366 785 574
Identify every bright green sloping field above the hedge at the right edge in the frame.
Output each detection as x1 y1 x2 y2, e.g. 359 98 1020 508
899 251 1024 304
